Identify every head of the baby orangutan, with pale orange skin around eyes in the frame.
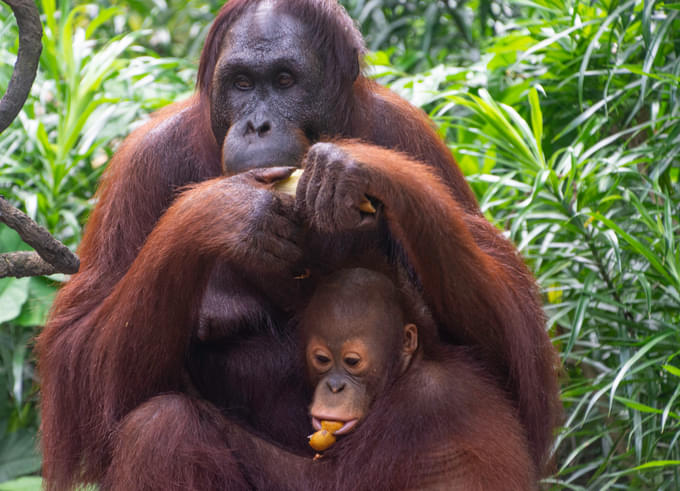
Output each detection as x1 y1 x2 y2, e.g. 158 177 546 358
302 268 418 435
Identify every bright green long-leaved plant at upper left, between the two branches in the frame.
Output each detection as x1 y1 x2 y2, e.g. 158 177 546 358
0 0 191 246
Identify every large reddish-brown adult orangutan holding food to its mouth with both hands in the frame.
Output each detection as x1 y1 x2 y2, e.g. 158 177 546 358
37 0 559 490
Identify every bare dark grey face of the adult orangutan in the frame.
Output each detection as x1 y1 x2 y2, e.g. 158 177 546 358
211 2 330 175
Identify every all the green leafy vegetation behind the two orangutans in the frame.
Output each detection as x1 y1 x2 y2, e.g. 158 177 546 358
0 0 680 490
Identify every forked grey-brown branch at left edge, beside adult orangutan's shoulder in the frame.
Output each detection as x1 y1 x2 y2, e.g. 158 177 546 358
0 196 80 278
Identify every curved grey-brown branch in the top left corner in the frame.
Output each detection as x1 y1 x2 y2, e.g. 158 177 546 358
0 0 42 133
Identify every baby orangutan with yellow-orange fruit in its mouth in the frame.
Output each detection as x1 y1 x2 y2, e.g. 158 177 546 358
220 268 537 491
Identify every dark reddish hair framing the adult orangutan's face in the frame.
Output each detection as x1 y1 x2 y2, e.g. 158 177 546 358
196 0 366 107
